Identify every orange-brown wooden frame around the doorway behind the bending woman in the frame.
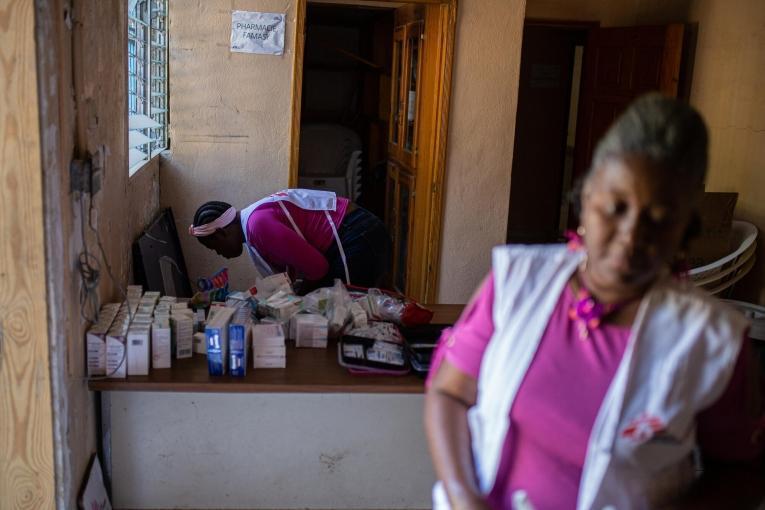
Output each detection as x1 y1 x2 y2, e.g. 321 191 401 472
289 0 458 303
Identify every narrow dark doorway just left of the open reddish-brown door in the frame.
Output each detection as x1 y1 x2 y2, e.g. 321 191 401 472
507 20 597 243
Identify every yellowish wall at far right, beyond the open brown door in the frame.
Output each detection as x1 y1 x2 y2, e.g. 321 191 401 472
688 0 765 304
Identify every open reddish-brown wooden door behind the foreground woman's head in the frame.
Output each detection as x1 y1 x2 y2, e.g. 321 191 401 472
574 24 685 183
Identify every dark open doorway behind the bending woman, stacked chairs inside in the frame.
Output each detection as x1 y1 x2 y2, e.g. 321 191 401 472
298 2 393 218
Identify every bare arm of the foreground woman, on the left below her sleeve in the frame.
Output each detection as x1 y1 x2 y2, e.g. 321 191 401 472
425 360 488 510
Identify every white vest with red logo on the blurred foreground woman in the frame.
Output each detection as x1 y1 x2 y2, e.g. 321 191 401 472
434 245 747 510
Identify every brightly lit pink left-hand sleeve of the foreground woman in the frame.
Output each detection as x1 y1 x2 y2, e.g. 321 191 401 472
427 273 494 385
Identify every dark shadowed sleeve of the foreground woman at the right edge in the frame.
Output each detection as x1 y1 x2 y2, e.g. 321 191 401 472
697 338 765 461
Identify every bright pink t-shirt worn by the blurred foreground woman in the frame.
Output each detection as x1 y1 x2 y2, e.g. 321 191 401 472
431 275 763 510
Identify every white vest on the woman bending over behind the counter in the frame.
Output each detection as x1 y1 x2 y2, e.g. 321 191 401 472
239 188 351 285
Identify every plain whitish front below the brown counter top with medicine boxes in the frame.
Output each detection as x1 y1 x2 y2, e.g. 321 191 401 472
109 392 435 509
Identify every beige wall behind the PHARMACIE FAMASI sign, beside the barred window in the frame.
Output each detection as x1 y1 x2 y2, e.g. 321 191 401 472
160 0 296 288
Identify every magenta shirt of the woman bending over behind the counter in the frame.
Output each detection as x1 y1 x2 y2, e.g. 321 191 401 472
247 197 349 281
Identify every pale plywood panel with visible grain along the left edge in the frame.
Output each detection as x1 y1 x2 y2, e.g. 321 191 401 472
0 0 54 509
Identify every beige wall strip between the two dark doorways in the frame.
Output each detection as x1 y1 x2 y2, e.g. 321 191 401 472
438 0 525 303
